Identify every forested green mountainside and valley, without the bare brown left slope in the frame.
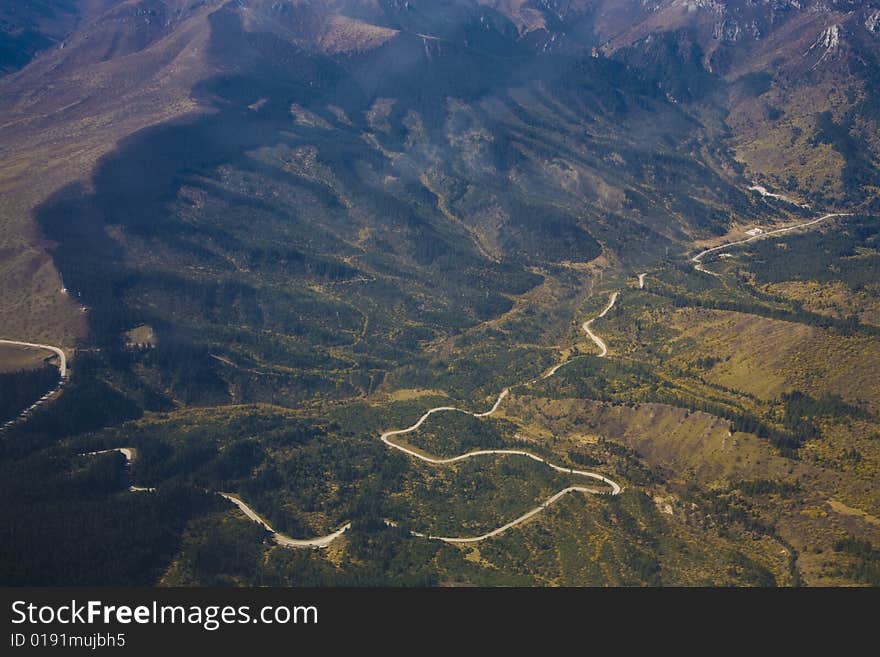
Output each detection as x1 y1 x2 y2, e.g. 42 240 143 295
0 0 880 586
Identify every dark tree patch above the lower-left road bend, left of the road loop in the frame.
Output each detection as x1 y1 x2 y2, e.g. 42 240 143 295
103 418 408 536
